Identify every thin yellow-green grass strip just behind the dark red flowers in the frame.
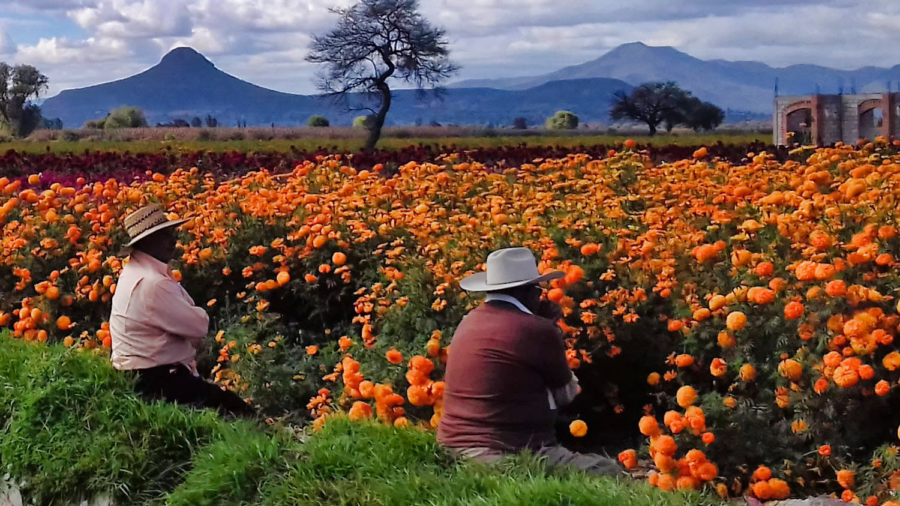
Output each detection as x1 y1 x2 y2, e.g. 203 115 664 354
0 133 772 153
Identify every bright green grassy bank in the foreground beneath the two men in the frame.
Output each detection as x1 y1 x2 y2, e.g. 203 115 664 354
0 336 717 506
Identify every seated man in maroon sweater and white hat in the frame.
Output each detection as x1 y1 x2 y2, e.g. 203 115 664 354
438 248 620 475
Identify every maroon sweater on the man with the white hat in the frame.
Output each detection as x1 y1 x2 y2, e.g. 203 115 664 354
438 302 572 451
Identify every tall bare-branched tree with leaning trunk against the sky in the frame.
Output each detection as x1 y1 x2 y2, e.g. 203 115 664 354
306 0 459 150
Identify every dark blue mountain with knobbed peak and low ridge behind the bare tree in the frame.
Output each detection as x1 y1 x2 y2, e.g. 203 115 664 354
43 48 631 128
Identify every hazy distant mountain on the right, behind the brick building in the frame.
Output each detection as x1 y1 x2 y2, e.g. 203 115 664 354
451 42 900 114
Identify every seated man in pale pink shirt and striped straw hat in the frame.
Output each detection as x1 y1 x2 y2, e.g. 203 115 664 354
109 205 253 415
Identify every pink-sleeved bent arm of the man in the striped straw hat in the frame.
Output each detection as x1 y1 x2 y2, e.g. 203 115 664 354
151 280 209 344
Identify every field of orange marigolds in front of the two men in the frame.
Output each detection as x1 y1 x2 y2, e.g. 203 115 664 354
8 139 900 506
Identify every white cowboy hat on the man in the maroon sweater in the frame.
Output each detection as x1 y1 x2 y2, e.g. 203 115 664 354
459 248 566 292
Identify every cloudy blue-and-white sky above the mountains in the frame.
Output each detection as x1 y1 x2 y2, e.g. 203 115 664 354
0 0 900 95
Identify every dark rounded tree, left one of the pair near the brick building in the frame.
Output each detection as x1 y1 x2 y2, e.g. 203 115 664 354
609 81 690 135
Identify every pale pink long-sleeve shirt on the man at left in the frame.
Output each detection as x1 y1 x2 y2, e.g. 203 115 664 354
109 251 209 371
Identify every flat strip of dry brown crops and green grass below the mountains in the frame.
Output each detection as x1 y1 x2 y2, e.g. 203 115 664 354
12 127 772 153
